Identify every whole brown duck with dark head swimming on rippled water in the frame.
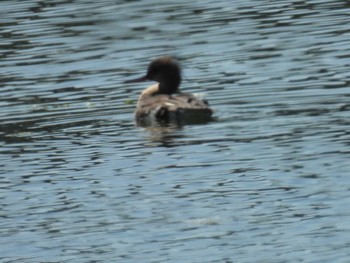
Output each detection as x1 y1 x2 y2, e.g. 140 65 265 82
125 56 213 125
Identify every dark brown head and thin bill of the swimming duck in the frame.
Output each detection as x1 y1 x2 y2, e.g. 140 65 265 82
127 57 181 94
